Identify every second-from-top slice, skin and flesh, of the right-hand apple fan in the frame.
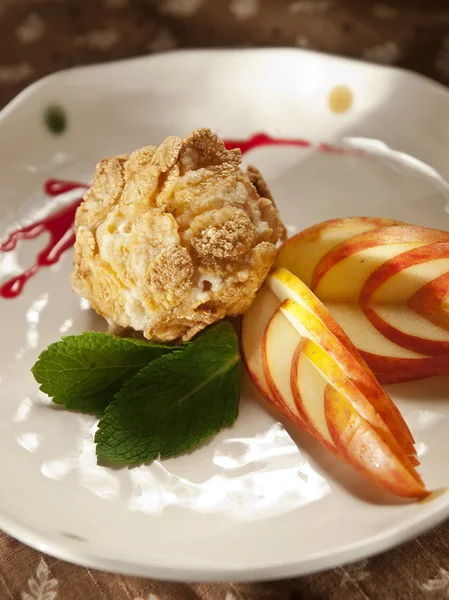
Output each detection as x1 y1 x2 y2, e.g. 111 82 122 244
312 225 449 303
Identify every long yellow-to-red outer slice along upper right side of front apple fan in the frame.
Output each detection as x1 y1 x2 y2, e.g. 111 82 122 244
266 269 417 464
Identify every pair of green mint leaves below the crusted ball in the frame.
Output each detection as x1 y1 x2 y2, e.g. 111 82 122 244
32 321 240 465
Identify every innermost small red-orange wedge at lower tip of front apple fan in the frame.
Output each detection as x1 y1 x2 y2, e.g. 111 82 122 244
324 385 429 499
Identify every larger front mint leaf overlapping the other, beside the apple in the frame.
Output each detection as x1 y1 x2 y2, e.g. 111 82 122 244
95 322 240 465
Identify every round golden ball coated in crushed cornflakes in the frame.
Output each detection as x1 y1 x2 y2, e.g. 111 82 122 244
72 129 285 341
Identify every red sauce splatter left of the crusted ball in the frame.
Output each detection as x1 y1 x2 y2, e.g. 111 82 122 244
0 179 87 298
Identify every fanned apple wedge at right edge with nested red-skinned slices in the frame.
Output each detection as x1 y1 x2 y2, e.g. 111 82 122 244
273 220 449 383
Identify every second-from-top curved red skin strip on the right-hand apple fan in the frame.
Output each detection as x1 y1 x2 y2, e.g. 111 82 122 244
311 225 449 290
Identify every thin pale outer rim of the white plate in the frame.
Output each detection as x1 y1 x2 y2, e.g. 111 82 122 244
0 46 449 582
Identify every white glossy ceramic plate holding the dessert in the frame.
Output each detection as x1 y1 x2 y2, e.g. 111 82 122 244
0 50 449 580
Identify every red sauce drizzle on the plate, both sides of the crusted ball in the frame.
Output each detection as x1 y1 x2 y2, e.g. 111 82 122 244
0 133 354 298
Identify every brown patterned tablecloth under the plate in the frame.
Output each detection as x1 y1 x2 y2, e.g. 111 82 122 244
0 0 449 600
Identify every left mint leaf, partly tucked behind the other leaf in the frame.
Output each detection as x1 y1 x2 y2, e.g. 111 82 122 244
31 332 174 415
